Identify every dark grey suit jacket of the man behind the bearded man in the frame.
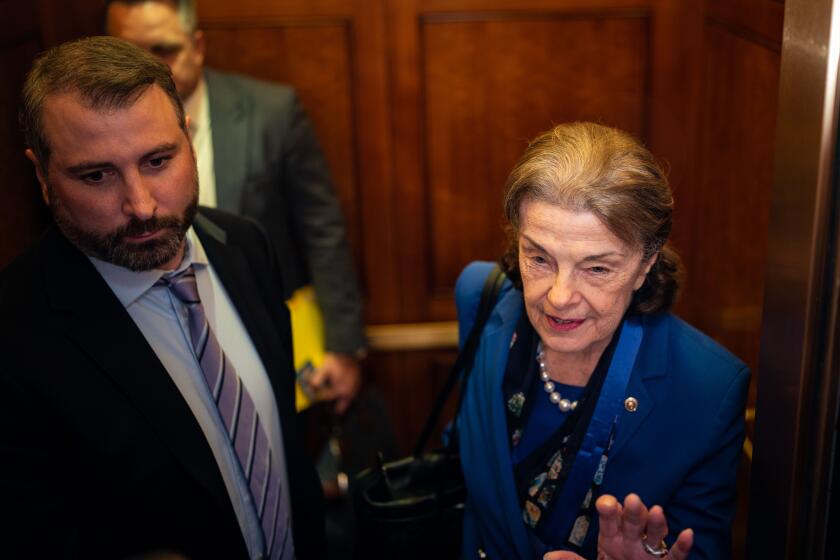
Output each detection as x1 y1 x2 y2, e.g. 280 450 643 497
204 69 364 354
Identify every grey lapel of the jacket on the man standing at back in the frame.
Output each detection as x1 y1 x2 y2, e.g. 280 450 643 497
204 70 251 213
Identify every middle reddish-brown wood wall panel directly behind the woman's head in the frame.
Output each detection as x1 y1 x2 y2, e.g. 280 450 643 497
391 1 704 321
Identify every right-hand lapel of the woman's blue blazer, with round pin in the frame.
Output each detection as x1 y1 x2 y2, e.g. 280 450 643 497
610 318 668 455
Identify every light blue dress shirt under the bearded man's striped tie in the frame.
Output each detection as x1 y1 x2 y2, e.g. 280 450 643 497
89 228 291 559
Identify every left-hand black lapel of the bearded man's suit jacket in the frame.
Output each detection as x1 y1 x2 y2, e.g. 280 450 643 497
46 230 230 507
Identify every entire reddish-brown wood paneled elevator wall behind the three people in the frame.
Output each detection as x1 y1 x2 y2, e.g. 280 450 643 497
0 0 784 552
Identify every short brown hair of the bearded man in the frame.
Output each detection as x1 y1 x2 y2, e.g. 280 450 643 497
19 37 186 174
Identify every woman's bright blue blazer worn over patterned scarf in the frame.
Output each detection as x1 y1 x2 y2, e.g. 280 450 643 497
455 262 749 560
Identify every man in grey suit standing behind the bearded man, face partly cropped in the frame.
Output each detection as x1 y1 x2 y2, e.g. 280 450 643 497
106 0 364 413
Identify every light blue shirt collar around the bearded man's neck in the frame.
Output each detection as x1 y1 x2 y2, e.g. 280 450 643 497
88 227 208 307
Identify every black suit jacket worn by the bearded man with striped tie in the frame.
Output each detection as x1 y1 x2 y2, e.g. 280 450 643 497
0 209 324 559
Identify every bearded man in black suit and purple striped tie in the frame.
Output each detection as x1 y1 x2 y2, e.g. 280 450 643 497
0 37 324 560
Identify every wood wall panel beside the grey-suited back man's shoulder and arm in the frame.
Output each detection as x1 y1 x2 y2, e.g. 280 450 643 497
200 0 401 323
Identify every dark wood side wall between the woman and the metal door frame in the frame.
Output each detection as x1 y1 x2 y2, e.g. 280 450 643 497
676 0 784 558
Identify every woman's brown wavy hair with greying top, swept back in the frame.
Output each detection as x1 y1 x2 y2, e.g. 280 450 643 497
501 122 682 314
